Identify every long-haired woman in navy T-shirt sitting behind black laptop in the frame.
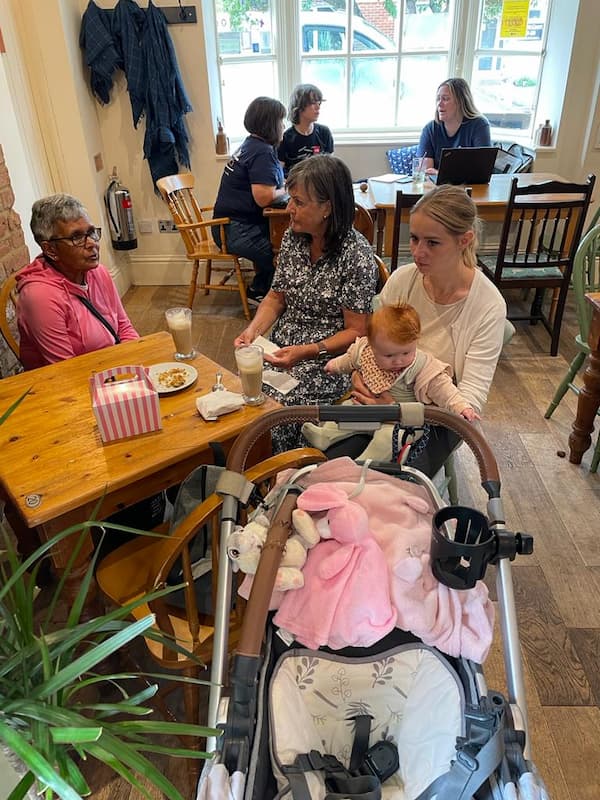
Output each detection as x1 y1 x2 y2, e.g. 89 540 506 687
418 78 492 175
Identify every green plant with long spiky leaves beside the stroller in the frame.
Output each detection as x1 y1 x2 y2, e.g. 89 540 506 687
0 390 219 800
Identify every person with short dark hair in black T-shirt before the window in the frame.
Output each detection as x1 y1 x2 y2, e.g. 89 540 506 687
277 83 333 176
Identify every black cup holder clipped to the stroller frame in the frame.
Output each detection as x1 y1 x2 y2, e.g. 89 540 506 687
430 506 533 589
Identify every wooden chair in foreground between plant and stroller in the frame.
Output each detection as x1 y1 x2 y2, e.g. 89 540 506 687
96 448 325 724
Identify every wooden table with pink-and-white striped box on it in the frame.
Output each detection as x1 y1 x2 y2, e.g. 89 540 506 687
0 332 279 593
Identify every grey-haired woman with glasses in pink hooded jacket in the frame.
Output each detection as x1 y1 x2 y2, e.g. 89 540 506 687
17 194 139 369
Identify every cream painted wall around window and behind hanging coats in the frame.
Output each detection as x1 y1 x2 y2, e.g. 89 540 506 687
0 0 600 289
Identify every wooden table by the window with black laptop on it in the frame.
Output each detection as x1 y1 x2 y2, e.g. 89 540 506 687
263 172 564 256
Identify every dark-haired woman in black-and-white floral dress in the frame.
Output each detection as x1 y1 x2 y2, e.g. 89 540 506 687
234 155 377 452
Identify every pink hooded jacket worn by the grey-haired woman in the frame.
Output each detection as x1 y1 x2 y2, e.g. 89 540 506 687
17 254 139 369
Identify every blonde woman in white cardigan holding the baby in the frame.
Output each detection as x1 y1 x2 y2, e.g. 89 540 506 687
327 185 506 476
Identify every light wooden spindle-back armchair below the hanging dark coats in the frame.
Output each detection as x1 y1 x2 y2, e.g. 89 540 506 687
156 172 253 319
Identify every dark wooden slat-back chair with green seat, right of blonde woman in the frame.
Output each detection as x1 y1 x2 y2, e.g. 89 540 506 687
478 175 596 356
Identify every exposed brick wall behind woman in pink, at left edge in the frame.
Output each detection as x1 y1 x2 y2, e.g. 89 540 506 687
0 145 29 377
